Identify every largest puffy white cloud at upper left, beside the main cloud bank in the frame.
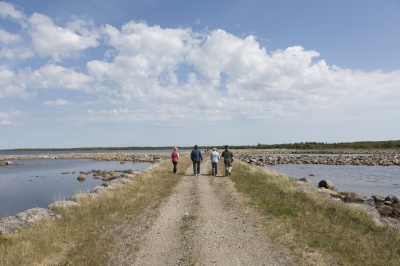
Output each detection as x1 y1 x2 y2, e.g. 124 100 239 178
29 13 98 61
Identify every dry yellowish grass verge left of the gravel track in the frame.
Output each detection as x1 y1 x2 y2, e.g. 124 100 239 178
0 156 190 265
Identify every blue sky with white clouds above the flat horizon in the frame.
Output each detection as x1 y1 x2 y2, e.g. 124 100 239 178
0 0 400 149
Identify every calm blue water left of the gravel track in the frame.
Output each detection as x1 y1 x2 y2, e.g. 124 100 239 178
0 158 151 218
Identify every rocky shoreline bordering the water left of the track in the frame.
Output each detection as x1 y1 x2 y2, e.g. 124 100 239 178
0 153 170 236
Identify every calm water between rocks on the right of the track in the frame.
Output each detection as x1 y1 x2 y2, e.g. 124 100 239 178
263 164 400 197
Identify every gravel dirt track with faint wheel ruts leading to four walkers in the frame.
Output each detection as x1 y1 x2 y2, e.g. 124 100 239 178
112 160 295 265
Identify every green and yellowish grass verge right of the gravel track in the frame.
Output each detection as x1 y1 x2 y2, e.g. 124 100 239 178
231 162 400 265
